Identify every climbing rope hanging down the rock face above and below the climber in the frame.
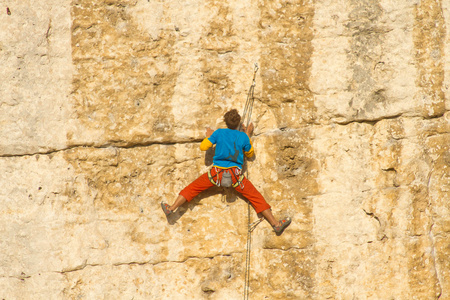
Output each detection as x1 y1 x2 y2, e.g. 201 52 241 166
243 63 264 300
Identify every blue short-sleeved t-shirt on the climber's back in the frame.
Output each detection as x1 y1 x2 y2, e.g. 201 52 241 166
208 128 252 169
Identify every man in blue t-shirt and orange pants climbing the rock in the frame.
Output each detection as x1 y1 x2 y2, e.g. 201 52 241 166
161 109 291 233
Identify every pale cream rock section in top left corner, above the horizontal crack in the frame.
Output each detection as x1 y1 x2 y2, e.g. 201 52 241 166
0 0 73 155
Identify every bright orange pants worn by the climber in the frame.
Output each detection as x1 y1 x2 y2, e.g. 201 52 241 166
180 168 270 213
